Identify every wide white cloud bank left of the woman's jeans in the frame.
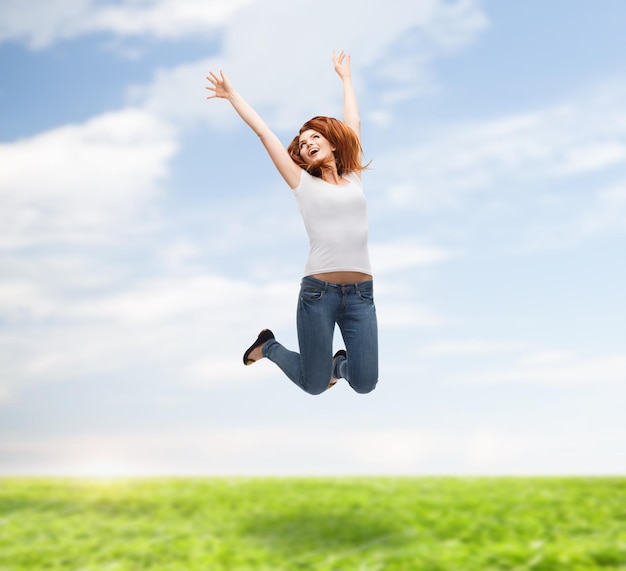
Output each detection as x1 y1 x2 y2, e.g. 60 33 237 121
0 272 295 388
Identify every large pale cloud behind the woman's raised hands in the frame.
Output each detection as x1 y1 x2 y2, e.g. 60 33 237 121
130 0 486 130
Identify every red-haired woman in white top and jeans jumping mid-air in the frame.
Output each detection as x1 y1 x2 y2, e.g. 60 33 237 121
207 51 378 395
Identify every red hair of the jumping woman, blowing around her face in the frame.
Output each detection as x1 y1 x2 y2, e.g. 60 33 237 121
287 116 367 178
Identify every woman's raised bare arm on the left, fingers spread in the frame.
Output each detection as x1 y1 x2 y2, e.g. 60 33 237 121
207 71 301 188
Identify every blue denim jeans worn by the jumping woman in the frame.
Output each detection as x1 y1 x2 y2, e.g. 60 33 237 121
263 276 378 395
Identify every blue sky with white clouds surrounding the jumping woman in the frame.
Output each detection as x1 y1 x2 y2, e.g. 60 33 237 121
0 0 626 475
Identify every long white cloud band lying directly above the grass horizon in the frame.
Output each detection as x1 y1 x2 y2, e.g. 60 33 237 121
0 424 626 476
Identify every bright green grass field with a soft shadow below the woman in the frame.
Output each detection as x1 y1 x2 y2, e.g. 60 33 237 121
0 477 626 571
